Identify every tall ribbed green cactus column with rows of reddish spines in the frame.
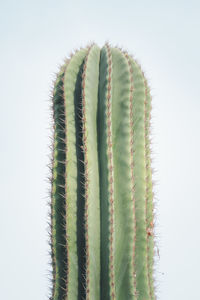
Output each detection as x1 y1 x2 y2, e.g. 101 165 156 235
50 43 156 300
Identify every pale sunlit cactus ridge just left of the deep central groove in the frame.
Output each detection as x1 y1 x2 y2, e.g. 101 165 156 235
82 45 100 300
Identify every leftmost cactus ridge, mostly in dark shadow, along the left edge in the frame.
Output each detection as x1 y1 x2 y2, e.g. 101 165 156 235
51 68 67 299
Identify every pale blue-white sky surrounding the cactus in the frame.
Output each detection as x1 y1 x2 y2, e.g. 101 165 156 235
0 0 200 300
